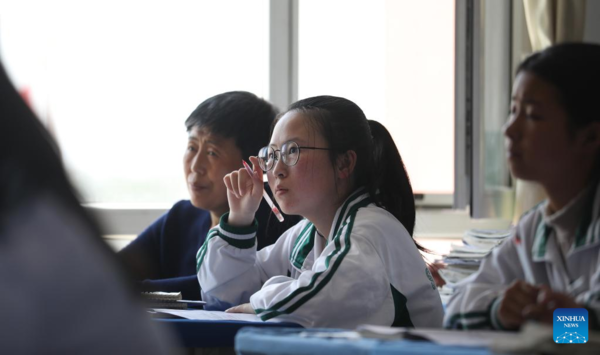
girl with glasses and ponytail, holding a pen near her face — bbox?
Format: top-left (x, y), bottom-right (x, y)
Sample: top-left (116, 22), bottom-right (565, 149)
top-left (197, 96), bottom-right (443, 328)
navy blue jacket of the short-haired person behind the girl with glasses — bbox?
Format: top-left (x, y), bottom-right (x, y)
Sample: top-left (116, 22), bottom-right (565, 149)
top-left (119, 200), bottom-right (300, 300)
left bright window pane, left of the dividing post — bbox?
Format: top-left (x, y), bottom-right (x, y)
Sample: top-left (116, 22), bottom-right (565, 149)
top-left (0, 0), bottom-right (269, 206)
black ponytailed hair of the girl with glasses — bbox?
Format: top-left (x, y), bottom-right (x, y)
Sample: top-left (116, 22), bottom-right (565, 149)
top-left (288, 96), bottom-right (425, 243)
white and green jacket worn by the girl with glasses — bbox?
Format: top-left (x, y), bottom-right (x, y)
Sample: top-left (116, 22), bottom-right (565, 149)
top-left (197, 190), bottom-right (443, 328)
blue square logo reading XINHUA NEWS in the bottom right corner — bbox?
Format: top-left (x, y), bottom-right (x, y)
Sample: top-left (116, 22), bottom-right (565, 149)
top-left (552, 308), bottom-right (588, 344)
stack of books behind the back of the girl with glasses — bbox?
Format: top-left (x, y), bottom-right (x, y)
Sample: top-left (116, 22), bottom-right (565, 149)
top-left (438, 229), bottom-right (512, 300)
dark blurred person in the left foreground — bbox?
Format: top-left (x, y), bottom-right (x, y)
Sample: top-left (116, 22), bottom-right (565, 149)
top-left (0, 60), bottom-right (176, 354)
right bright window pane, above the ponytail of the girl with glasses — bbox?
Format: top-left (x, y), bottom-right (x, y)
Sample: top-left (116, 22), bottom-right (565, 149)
top-left (298, 0), bottom-right (455, 197)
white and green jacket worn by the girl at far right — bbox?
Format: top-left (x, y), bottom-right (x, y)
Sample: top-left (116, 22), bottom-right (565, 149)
top-left (444, 182), bottom-right (600, 329)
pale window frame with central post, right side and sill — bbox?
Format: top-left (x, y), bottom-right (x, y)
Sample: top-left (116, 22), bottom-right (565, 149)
top-left (91, 0), bottom-right (512, 234)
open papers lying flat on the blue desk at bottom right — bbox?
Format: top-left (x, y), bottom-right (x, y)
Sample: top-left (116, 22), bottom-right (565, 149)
top-left (356, 325), bottom-right (518, 347)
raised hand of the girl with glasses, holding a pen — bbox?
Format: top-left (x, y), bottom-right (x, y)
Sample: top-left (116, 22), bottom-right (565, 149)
top-left (223, 157), bottom-right (283, 227)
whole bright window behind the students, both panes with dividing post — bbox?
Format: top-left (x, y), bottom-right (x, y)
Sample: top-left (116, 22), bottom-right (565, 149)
top-left (0, 0), bottom-right (511, 233)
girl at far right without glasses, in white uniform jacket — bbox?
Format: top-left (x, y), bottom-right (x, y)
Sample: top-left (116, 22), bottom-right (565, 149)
top-left (444, 44), bottom-right (600, 329)
